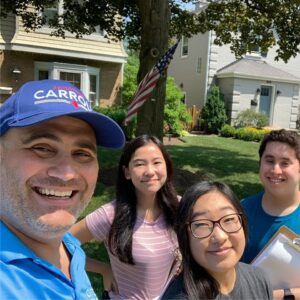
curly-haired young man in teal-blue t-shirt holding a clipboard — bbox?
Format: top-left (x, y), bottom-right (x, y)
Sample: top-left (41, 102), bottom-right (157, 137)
top-left (242, 129), bottom-right (300, 299)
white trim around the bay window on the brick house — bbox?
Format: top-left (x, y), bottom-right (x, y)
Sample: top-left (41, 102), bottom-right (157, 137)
top-left (34, 61), bottom-right (100, 106)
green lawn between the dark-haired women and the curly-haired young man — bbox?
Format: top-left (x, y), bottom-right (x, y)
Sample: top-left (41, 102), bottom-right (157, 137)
top-left (167, 135), bottom-right (261, 198)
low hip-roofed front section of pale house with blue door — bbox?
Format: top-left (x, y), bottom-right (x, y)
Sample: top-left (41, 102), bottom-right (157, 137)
top-left (216, 56), bottom-right (300, 129)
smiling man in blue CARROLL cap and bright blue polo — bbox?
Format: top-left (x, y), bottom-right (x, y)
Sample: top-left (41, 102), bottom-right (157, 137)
top-left (0, 80), bottom-right (124, 299)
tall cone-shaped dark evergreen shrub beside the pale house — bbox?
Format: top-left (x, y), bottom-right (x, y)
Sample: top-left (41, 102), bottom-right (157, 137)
top-left (200, 86), bottom-right (227, 133)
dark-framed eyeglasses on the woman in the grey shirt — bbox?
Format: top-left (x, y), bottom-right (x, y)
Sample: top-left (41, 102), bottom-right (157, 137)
top-left (189, 213), bottom-right (242, 239)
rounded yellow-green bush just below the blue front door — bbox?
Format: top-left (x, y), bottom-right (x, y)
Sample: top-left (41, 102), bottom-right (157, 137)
top-left (234, 108), bottom-right (269, 128)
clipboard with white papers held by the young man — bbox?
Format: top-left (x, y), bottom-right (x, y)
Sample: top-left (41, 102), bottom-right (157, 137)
top-left (251, 226), bottom-right (300, 289)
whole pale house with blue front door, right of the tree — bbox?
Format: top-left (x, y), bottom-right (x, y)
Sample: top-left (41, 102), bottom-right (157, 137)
top-left (168, 1), bottom-right (300, 129)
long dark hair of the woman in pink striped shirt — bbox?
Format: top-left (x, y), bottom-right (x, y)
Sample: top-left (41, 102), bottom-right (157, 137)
top-left (108, 135), bottom-right (178, 265)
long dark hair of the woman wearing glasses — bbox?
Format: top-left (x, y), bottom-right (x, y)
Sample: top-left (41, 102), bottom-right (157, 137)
top-left (176, 181), bottom-right (248, 299)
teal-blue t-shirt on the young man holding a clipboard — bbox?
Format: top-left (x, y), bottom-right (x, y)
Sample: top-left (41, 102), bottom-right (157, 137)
top-left (241, 192), bottom-right (300, 263)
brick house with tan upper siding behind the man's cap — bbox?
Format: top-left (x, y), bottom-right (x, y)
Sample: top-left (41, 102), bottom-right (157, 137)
top-left (0, 6), bottom-right (127, 106)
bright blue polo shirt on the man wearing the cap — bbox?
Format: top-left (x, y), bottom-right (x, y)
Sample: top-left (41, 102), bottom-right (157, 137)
top-left (0, 222), bottom-right (97, 300)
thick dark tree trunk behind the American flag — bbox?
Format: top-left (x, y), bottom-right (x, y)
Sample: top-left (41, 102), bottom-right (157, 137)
top-left (136, 0), bottom-right (170, 139)
